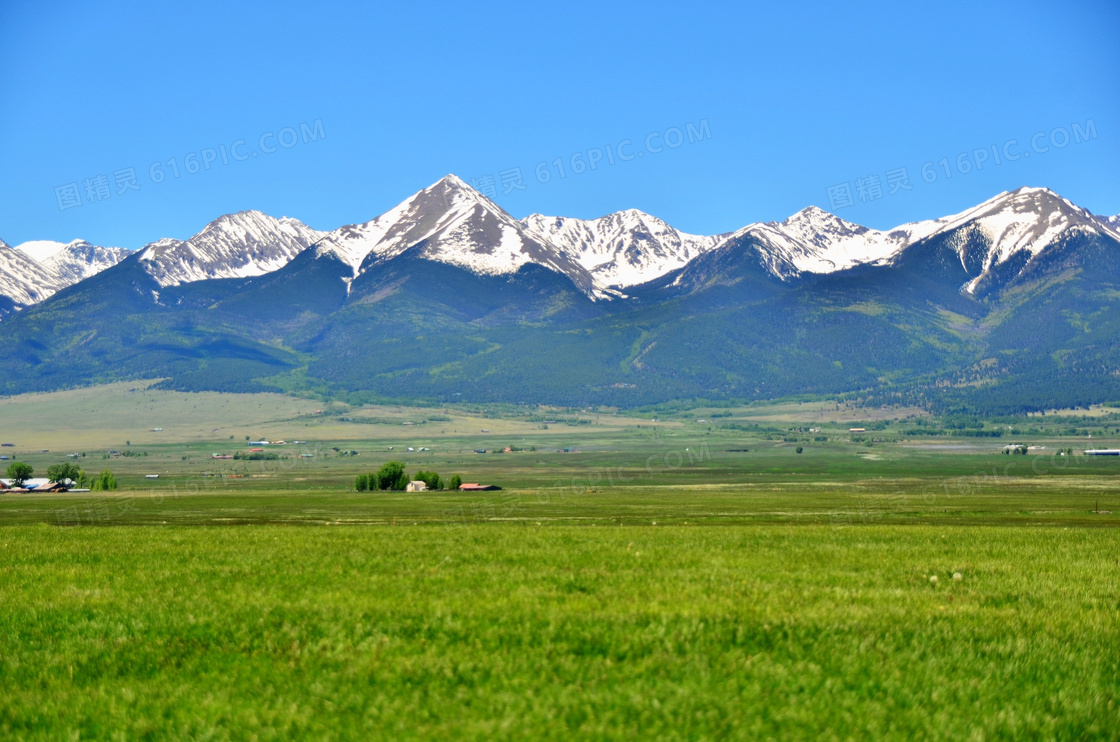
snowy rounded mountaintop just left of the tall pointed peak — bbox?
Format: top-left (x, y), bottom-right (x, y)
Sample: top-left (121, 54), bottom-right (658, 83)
top-left (140, 211), bottom-right (325, 286)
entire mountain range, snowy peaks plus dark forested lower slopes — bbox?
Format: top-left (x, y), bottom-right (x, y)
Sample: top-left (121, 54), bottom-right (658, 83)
top-left (0, 176), bottom-right (1120, 411)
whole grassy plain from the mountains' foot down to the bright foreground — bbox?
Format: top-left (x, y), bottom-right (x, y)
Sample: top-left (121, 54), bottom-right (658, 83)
top-left (0, 386), bottom-right (1120, 740)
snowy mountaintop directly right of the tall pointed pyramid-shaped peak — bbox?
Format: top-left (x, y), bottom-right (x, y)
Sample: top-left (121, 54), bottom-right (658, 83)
top-left (521, 208), bottom-right (720, 289)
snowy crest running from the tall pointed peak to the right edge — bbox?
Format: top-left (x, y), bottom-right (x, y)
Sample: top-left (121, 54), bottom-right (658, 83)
top-left (252, 182), bottom-right (1117, 298)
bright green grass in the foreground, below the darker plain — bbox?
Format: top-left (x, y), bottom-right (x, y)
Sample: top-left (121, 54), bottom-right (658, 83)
top-left (0, 526), bottom-right (1120, 739)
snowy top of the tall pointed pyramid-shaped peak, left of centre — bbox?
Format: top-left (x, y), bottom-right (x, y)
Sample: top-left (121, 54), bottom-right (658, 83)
top-left (316, 175), bottom-right (594, 291)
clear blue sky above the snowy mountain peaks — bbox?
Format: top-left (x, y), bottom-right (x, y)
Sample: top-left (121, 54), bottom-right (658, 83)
top-left (0, 0), bottom-right (1120, 248)
